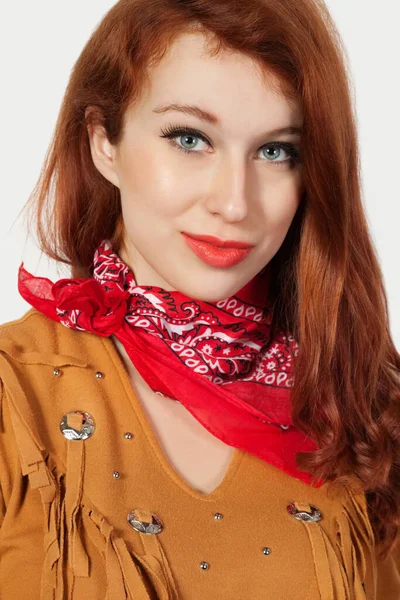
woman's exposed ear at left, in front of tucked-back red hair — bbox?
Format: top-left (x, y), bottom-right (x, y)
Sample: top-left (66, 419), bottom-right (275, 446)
top-left (85, 107), bottom-right (120, 188)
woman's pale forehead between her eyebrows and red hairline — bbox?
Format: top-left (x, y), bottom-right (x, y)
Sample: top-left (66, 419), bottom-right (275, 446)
top-left (134, 32), bottom-right (301, 127)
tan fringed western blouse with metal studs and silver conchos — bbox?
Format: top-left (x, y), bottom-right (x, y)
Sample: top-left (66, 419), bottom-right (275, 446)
top-left (0, 309), bottom-right (400, 600)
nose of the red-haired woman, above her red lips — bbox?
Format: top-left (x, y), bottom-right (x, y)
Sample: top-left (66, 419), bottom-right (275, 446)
top-left (207, 158), bottom-right (250, 223)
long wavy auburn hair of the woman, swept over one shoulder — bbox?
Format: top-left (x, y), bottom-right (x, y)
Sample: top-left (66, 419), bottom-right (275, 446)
top-left (21, 0), bottom-right (400, 558)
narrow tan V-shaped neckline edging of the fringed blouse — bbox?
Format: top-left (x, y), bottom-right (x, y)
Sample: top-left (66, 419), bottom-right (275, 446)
top-left (100, 337), bottom-right (246, 502)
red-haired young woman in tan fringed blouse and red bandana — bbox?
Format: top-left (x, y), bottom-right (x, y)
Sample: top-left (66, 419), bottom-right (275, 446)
top-left (0, 0), bottom-right (400, 600)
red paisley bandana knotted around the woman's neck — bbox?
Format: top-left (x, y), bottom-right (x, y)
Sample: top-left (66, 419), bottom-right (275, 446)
top-left (18, 240), bottom-right (323, 487)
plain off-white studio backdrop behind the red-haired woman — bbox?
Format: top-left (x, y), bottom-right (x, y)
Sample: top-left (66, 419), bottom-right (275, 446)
top-left (0, 0), bottom-right (400, 350)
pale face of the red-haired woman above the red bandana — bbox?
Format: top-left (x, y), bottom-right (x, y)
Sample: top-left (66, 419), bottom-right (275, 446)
top-left (89, 33), bottom-right (303, 302)
